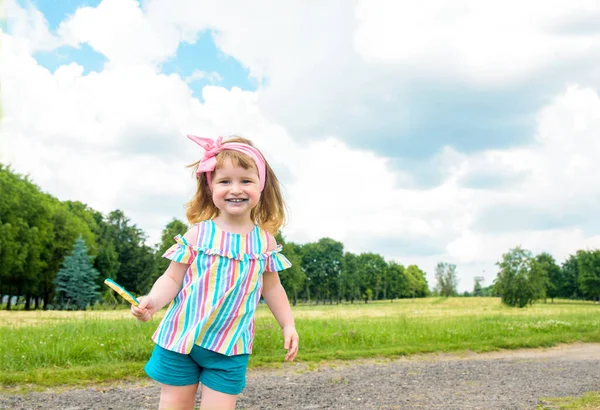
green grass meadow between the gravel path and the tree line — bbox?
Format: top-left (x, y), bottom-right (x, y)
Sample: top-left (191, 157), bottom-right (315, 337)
top-left (0, 298), bottom-right (600, 389)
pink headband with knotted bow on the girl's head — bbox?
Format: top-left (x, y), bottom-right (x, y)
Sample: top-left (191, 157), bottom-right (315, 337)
top-left (187, 134), bottom-right (267, 192)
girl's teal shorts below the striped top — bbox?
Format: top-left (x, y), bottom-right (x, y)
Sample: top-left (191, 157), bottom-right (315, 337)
top-left (144, 345), bottom-right (250, 394)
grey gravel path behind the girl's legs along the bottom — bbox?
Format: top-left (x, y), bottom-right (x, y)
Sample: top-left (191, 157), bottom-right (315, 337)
top-left (0, 344), bottom-right (600, 410)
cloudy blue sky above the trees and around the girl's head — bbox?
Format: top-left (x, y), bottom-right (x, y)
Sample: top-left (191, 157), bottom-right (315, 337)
top-left (0, 0), bottom-right (600, 292)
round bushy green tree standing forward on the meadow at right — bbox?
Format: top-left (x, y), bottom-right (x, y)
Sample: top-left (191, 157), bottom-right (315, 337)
top-left (495, 246), bottom-right (547, 307)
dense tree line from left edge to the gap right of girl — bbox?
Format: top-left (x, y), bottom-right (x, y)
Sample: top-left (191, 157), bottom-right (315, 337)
top-left (0, 164), bottom-right (429, 310)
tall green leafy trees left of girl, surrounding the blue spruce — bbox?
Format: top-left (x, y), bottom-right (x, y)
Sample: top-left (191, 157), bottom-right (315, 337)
top-left (0, 164), bottom-right (156, 309)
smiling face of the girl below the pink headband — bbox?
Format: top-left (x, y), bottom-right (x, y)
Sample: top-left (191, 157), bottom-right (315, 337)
top-left (212, 160), bottom-right (260, 218)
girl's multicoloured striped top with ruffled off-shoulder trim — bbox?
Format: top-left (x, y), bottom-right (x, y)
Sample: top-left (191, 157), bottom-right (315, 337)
top-left (152, 220), bottom-right (292, 356)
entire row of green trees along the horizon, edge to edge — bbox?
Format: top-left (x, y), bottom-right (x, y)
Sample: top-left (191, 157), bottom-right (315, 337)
top-left (0, 164), bottom-right (600, 309)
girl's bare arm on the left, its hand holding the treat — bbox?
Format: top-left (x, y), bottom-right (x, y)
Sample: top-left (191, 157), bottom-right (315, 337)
top-left (131, 228), bottom-right (197, 322)
